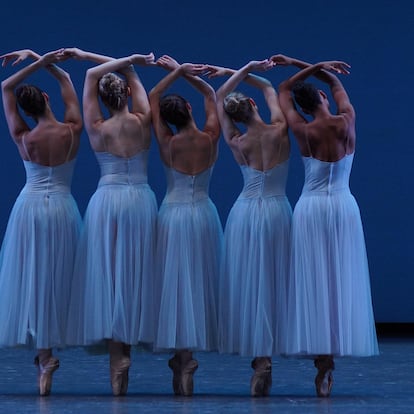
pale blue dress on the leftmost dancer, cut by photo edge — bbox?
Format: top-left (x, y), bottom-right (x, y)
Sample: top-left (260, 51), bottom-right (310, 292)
top-left (0, 160), bottom-right (81, 349)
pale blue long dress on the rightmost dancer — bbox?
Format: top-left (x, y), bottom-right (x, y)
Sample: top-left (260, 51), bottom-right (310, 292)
top-left (286, 154), bottom-right (378, 356)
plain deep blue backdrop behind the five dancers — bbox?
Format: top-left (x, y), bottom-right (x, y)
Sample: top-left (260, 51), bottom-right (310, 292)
top-left (0, 0), bottom-right (414, 322)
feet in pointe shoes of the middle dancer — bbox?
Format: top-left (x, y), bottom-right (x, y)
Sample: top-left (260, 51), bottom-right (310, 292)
top-left (168, 351), bottom-right (198, 397)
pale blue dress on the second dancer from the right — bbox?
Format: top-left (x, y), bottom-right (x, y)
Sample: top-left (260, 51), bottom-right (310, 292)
top-left (219, 160), bottom-right (292, 357)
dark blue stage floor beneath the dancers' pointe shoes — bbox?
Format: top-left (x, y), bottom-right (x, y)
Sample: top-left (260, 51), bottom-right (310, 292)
top-left (0, 337), bottom-right (414, 414)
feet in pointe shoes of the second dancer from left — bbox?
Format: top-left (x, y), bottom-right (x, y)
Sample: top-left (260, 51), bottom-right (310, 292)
top-left (109, 341), bottom-right (131, 396)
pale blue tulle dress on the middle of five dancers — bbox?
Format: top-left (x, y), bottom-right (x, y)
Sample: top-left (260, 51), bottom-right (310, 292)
top-left (156, 167), bottom-right (222, 351)
